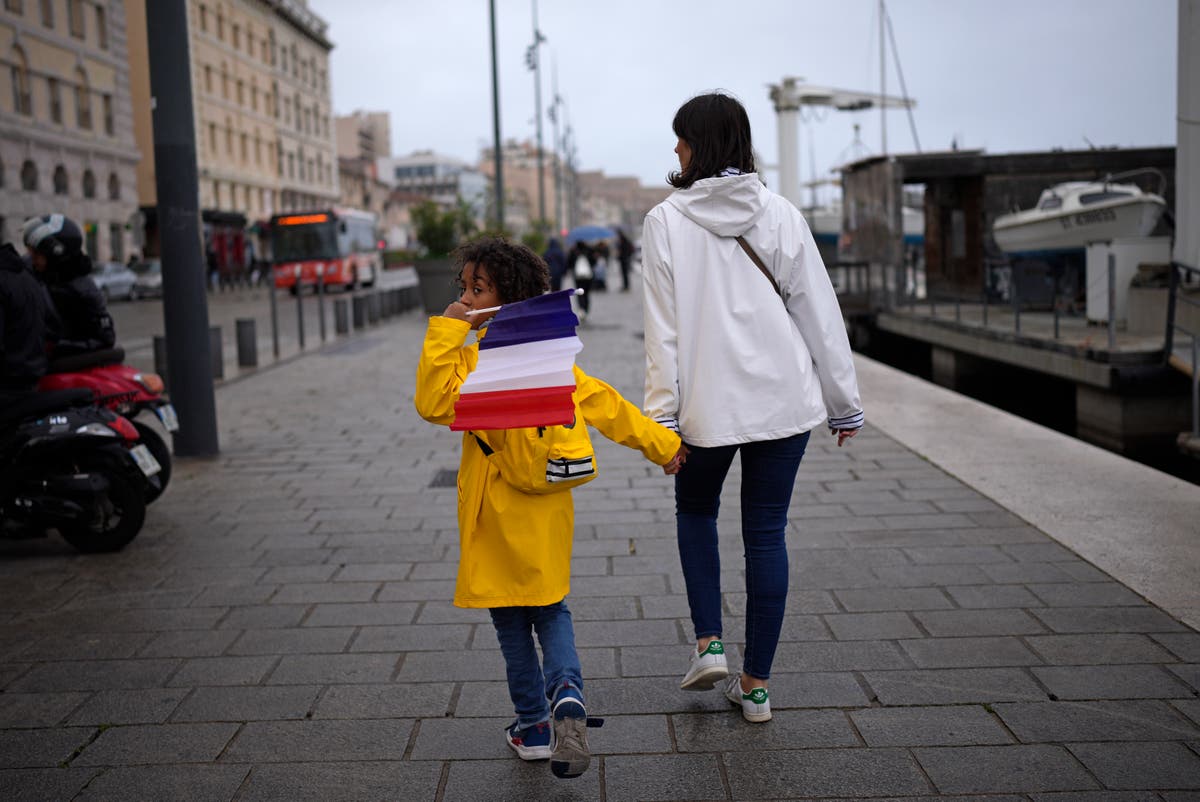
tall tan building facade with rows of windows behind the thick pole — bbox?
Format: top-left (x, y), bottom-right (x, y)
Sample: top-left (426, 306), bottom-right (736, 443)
top-left (125, 0), bottom-right (338, 230)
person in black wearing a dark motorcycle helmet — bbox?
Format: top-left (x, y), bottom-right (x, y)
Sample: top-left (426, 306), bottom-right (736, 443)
top-left (22, 215), bottom-right (116, 359)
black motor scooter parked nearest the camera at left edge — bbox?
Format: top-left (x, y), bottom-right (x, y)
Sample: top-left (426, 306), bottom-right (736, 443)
top-left (0, 390), bottom-right (160, 552)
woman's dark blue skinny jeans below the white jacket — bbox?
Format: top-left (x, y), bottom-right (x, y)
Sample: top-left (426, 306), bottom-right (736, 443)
top-left (676, 432), bottom-right (810, 680)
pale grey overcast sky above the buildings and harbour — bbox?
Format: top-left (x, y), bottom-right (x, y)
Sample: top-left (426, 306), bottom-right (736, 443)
top-left (310, 0), bottom-right (1177, 199)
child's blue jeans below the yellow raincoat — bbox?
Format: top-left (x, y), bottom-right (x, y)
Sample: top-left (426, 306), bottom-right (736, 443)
top-left (488, 602), bottom-right (583, 729)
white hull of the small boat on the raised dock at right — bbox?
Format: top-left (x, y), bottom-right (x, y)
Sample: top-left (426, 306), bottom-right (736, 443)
top-left (992, 198), bottom-right (1165, 253)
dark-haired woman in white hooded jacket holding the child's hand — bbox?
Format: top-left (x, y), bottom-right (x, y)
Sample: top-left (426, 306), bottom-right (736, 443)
top-left (642, 94), bottom-right (863, 722)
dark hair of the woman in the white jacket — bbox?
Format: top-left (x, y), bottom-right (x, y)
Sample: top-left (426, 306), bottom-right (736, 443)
top-left (667, 92), bottom-right (755, 190)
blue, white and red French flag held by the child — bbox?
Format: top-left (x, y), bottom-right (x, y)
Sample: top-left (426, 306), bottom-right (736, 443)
top-left (450, 289), bottom-right (583, 431)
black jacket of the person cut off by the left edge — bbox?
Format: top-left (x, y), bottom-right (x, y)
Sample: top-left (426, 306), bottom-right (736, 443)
top-left (0, 244), bottom-right (54, 391)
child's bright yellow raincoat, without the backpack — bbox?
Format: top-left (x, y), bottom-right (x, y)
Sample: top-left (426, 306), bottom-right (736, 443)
top-left (414, 317), bottom-right (679, 608)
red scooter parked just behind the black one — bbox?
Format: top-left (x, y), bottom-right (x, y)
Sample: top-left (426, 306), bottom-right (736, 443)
top-left (37, 348), bottom-right (179, 503)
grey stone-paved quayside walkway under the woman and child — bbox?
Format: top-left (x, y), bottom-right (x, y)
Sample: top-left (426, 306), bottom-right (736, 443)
top-left (0, 282), bottom-right (1200, 801)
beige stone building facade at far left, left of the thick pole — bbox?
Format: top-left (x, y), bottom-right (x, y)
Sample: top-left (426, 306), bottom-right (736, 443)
top-left (0, 0), bottom-right (138, 261)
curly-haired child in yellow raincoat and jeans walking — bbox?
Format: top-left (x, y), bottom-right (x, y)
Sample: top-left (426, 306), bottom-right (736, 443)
top-left (415, 238), bottom-right (684, 777)
